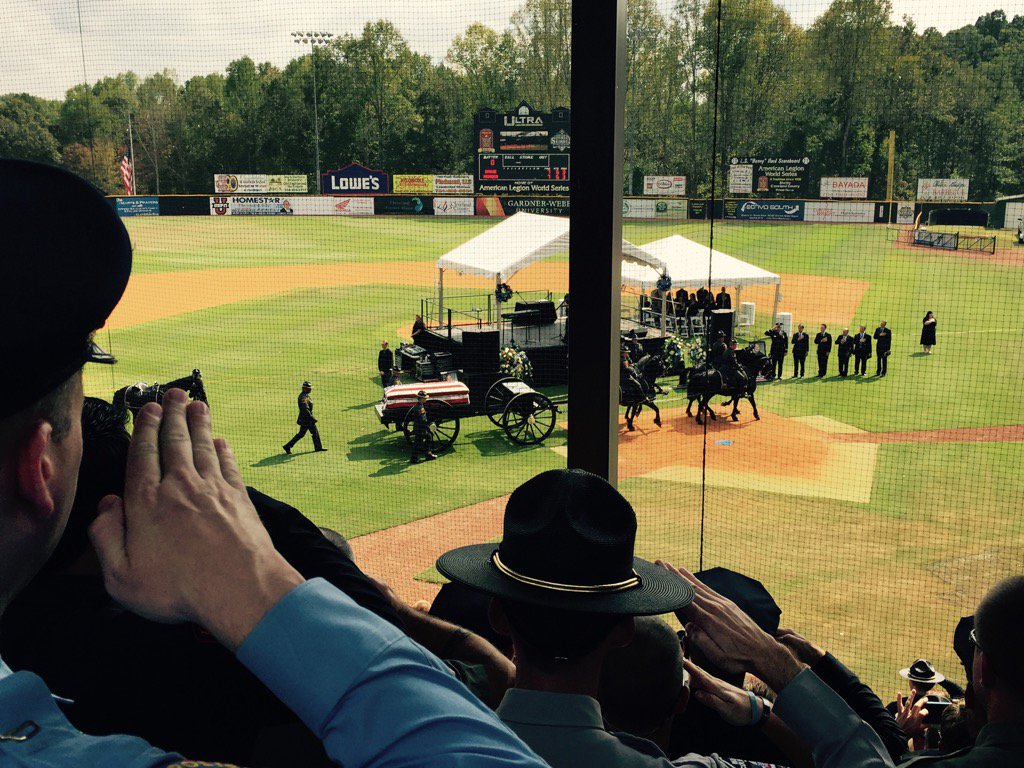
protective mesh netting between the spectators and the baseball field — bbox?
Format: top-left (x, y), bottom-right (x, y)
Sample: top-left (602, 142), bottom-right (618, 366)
top-left (0, 0), bottom-right (1024, 716)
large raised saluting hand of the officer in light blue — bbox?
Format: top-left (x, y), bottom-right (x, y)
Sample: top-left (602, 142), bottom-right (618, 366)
top-left (89, 389), bottom-right (302, 650)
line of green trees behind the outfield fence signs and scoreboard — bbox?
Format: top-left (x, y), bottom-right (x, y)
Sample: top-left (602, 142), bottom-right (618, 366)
top-left (0, 0), bottom-right (1024, 200)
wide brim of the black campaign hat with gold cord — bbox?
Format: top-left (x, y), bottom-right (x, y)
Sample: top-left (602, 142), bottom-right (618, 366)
top-left (437, 544), bottom-right (693, 616)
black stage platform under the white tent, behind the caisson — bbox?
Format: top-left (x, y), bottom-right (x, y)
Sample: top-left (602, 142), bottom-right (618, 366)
top-left (415, 317), bottom-right (670, 386)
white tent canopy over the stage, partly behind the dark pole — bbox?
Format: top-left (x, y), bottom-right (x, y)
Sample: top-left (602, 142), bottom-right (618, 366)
top-left (437, 212), bottom-right (664, 281)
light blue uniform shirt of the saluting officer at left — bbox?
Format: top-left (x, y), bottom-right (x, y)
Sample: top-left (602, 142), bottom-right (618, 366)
top-left (0, 579), bottom-right (546, 768)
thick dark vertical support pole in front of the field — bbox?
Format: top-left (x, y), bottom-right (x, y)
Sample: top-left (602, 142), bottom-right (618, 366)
top-left (569, 0), bottom-right (626, 484)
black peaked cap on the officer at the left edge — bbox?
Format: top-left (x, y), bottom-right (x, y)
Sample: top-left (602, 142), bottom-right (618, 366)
top-left (0, 159), bottom-right (131, 419)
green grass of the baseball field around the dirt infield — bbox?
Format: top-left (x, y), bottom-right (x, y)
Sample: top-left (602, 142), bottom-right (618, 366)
top-left (86, 217), bottom-right (1024, 690)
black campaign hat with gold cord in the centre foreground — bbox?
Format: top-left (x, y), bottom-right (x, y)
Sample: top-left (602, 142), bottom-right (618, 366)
top-left (437, 469), bottom-right (693, 615)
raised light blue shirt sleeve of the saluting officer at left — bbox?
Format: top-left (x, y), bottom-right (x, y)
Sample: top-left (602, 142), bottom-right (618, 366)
top-left (238, 579), bottom-right (545, 768)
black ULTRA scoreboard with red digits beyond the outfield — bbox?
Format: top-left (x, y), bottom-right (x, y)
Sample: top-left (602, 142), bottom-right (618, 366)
top-left (473, 101), bottom-right (570, 196)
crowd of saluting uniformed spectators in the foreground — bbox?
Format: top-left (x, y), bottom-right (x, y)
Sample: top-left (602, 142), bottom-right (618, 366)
top-left (0, 160), bottom-right (1024, 768)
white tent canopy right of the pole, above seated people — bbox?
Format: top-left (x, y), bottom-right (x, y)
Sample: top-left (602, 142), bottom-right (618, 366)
top-left (623, 234), bottom-right (781, 288)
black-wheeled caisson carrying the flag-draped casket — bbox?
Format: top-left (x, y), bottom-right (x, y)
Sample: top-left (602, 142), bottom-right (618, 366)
top-left (374, 376), bottom-right (565, 453)
